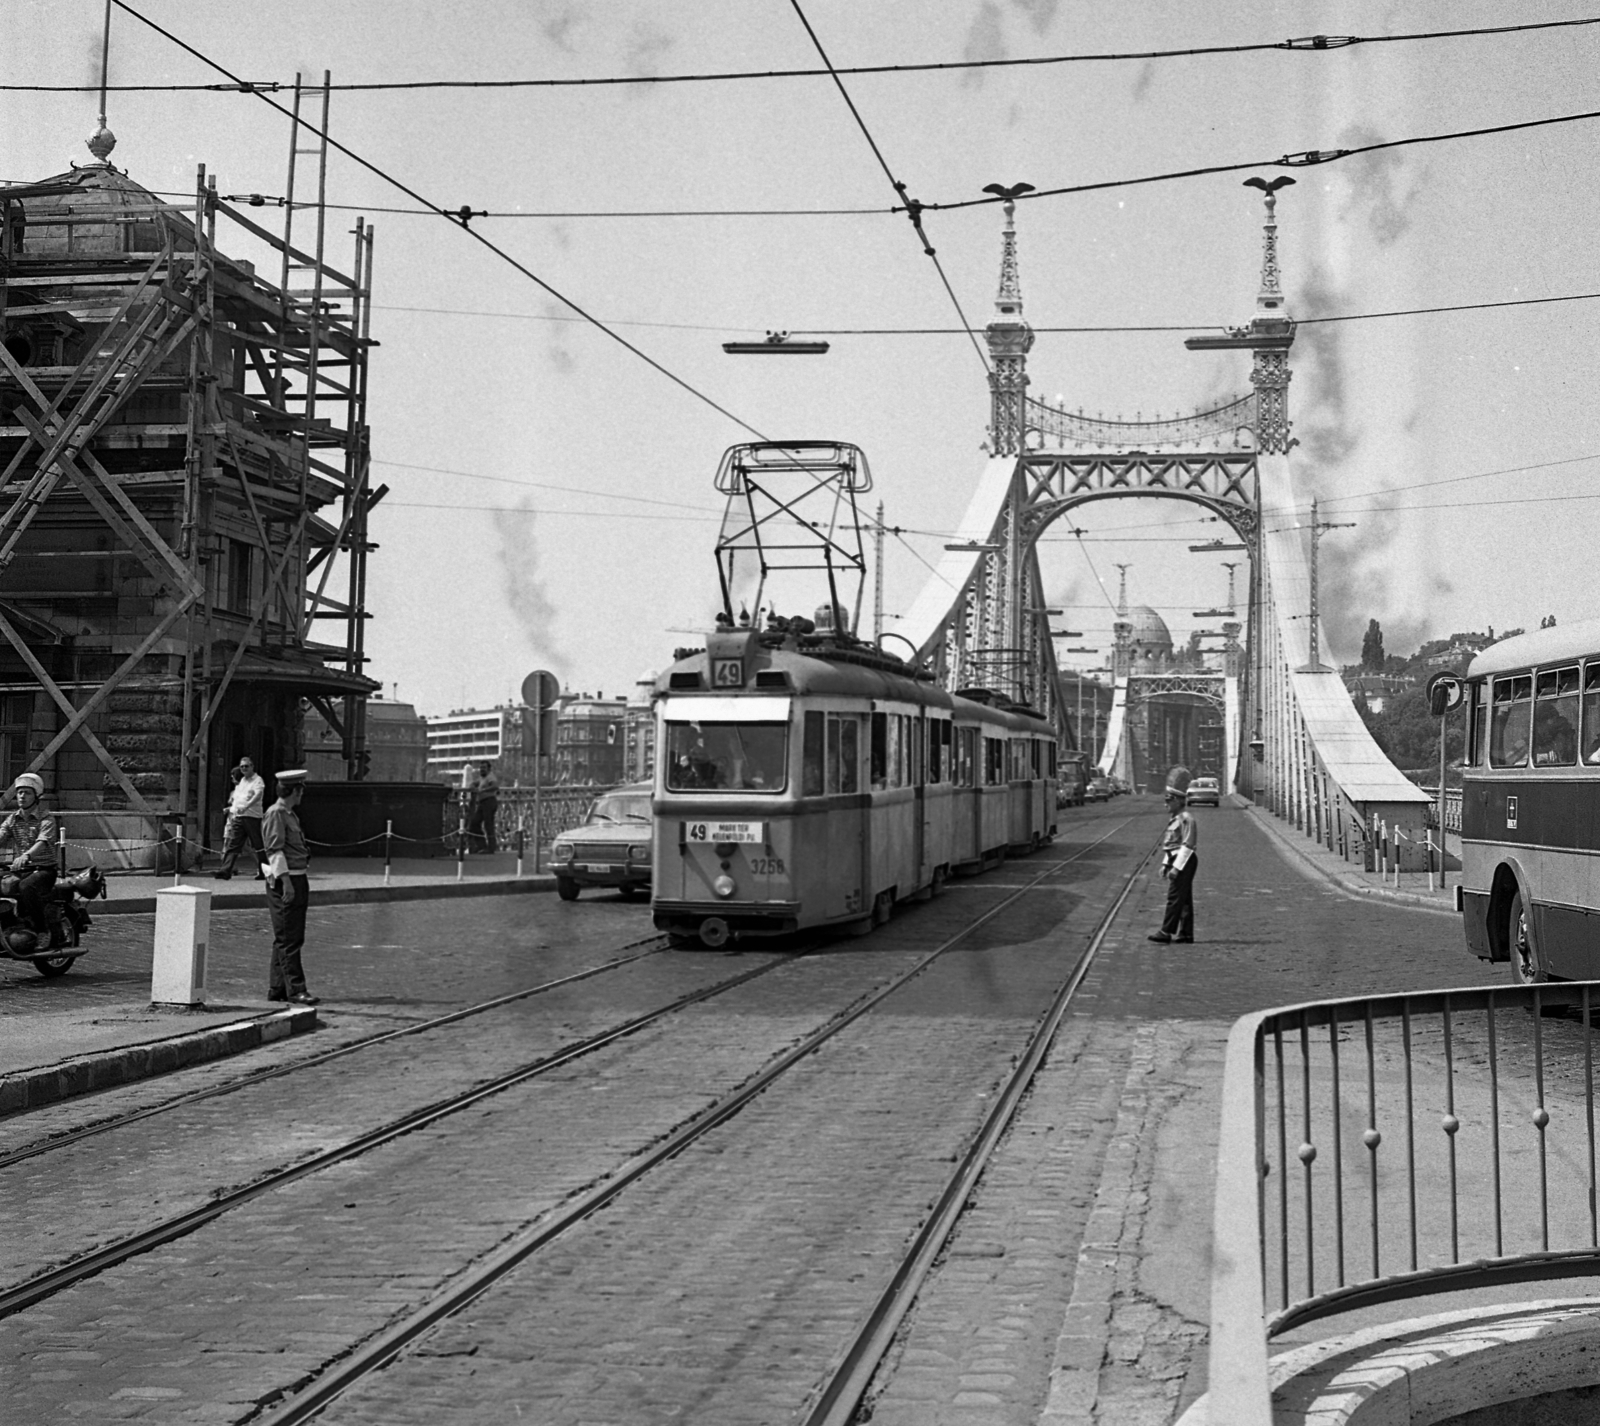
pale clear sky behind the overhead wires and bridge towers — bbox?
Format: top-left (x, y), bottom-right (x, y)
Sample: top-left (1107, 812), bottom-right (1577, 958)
top-left (0, 0), bottom-right (1600, 714)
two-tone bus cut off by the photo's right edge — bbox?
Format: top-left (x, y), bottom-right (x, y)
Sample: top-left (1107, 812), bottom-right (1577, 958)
top-left (1458, 619), bottom-right (1600, 983)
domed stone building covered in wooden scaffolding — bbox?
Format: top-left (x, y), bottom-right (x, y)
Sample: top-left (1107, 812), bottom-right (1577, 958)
top-left (0, 100), bottom-right (382, 864)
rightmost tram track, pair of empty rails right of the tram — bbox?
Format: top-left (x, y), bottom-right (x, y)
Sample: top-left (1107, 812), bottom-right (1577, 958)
top-left (245, 818), bottom-right (1154, 1426)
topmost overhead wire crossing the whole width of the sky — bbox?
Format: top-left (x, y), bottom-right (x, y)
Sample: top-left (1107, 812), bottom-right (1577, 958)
top-left (0, 18), bottom-right (1600, 94)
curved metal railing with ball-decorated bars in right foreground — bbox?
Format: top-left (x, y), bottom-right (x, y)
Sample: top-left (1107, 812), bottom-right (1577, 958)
top-left (1208, 981), bottom-right (1600, 1426)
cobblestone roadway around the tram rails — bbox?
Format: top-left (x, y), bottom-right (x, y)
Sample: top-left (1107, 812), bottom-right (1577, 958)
top-left (0, 800), bottom-right (1486, 1426)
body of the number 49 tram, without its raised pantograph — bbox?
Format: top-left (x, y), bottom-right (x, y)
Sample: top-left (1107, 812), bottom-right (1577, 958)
top-left (651, 610), bottom-right (1056, 947)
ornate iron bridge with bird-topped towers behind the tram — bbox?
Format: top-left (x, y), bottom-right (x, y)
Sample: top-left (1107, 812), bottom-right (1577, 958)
top-left (888, 190), bottom-right (1429, 866)
